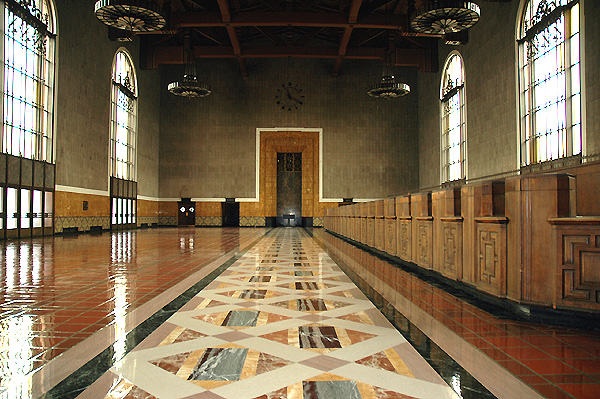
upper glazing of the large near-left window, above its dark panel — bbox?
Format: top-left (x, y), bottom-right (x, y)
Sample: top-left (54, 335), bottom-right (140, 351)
top-left (2, 0), bottom-right (55, 162)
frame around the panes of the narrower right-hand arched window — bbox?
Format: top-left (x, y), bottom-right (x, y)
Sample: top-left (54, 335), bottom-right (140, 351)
top-left (439, 50), bottom-right (468, 185)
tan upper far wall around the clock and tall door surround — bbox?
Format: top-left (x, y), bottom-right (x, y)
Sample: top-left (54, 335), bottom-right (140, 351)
top-left (160, 59), bottom-right (418, 202)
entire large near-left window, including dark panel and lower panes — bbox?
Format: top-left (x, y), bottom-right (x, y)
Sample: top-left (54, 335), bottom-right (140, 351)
top-left (0, 0), bottom-right (56, 238)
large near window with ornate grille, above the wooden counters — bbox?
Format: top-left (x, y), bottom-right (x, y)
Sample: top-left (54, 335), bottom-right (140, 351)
top-left (518, 0), bottom-right (582, 166)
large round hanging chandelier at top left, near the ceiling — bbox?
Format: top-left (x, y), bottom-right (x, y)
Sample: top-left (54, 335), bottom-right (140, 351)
top-left (94, 0), bottom-right (166, 32)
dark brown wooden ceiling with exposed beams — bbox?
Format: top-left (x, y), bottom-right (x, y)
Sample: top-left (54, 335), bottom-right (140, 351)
top-left (134, 0), bottom-right (510, 76)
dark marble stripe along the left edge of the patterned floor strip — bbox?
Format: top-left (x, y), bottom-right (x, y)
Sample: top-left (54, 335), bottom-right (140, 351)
top-left (41, 229), bottom-right (273, 399)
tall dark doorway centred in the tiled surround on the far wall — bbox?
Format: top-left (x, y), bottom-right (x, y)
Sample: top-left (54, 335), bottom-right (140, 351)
top-left (277, 152), bottom-right (302, 227)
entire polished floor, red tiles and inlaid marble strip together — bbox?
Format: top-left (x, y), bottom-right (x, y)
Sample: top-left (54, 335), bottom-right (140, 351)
top-left (0, 228), bottom-right (600, 399)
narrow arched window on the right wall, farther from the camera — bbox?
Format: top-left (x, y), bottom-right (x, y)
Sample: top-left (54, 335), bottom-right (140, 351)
top-left (440, 51), bottom-right (467, 183)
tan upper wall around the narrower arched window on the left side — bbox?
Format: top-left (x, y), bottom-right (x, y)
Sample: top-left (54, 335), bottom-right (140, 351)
top-left (55, 0), bottom-right (160, 197)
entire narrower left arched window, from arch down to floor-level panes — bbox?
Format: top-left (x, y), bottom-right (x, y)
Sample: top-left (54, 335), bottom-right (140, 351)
top-left (110, 49), bottom-right (137, 227)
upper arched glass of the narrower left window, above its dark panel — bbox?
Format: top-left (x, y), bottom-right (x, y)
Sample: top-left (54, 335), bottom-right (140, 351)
top-left (110, 50), bottom-right (137, 181)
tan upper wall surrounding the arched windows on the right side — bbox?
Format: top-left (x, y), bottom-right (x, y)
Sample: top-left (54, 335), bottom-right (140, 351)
top-left (419, 0), bottom-right (600, 188)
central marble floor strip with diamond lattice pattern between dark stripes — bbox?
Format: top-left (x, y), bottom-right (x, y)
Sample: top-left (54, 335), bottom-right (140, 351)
top-left (96, 229), bottom-right (458, 399)
